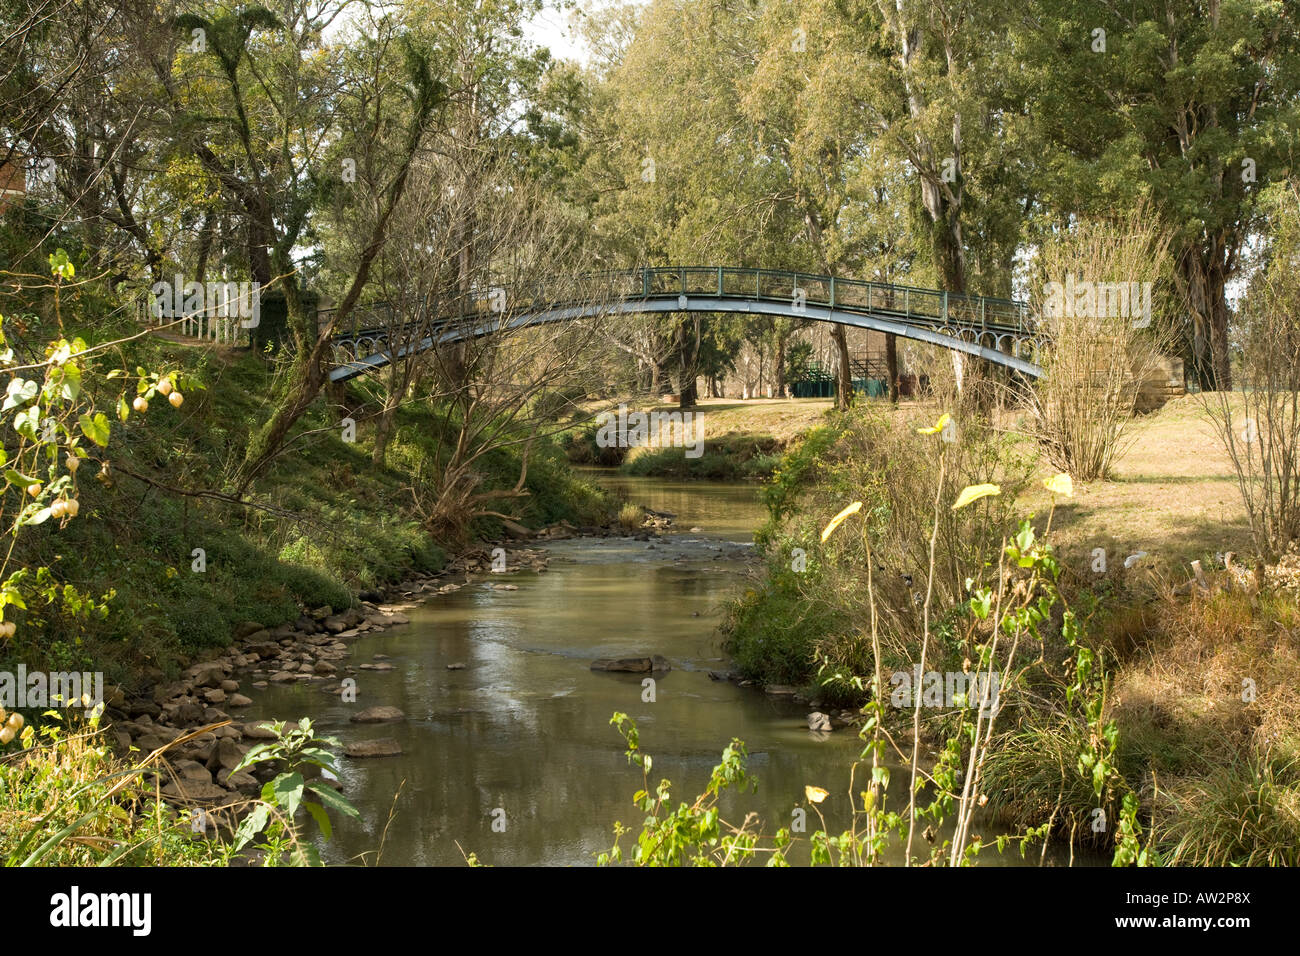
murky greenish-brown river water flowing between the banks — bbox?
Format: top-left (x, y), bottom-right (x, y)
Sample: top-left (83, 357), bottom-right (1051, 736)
top-left (247, 473), bottom-right (1076, 865)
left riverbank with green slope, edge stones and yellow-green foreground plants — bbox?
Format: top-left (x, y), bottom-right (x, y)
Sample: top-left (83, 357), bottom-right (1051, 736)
top-left (0, 323), bottom-right (611, 864)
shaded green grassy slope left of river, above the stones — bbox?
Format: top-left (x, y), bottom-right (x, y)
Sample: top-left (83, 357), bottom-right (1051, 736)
top-left (0, 316), bottom-right (608, 685)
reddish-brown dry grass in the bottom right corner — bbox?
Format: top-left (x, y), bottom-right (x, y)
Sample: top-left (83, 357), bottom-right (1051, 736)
top-left (1112, 591), bottom-right (1300, 866)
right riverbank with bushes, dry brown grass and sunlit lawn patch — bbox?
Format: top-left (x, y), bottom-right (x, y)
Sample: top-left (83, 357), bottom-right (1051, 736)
top-left (724, 398), bottom-right (1300, 865)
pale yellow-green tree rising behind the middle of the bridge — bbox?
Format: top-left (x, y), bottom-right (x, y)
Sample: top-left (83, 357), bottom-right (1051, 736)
top-left (586, 0), bottom-right (815, 402)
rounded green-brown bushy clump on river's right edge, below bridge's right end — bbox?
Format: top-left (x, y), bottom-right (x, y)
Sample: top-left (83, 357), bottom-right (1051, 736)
top-left (724, 397), bottom-right (1032, 700)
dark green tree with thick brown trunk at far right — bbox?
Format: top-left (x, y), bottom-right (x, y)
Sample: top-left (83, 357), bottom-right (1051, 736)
top-left (1014, 0), bottom-right (1300, 389)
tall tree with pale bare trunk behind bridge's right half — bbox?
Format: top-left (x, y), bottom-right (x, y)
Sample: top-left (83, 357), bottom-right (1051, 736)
top-left (818, 0), bottom-right (1032, 395)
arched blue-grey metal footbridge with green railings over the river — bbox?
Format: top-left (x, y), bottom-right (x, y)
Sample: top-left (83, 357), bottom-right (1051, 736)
top-left (329, 265), bottom-right (1047, 381)
